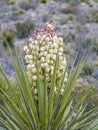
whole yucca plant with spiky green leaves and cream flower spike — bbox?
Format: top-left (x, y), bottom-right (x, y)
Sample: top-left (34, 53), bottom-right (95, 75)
top-left (0, 19), bottom-right (98, 130)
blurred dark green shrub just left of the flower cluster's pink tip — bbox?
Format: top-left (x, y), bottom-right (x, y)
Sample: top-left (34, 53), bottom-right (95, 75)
top-left (15, 21), bottom-right (34, 38)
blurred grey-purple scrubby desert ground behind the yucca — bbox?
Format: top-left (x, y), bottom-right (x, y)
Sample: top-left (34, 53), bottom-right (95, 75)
top-left (0, 0), bottom-right (98, 87)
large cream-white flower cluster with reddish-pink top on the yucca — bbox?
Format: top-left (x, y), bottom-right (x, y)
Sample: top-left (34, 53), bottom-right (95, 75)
top-left (24, 20), bottom-right (67, 98)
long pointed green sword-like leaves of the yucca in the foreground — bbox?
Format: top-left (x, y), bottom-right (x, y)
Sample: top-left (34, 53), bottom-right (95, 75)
top-left (0, 50), bottom-right (98, 130)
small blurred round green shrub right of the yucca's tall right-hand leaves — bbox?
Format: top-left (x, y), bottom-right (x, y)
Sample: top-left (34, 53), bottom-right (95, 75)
top-left (82, 62), bottom-right (94, 75)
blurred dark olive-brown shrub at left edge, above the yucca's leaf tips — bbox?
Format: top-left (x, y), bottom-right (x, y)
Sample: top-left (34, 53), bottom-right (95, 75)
top-left (0, 29), bottom-right (15, 48)
